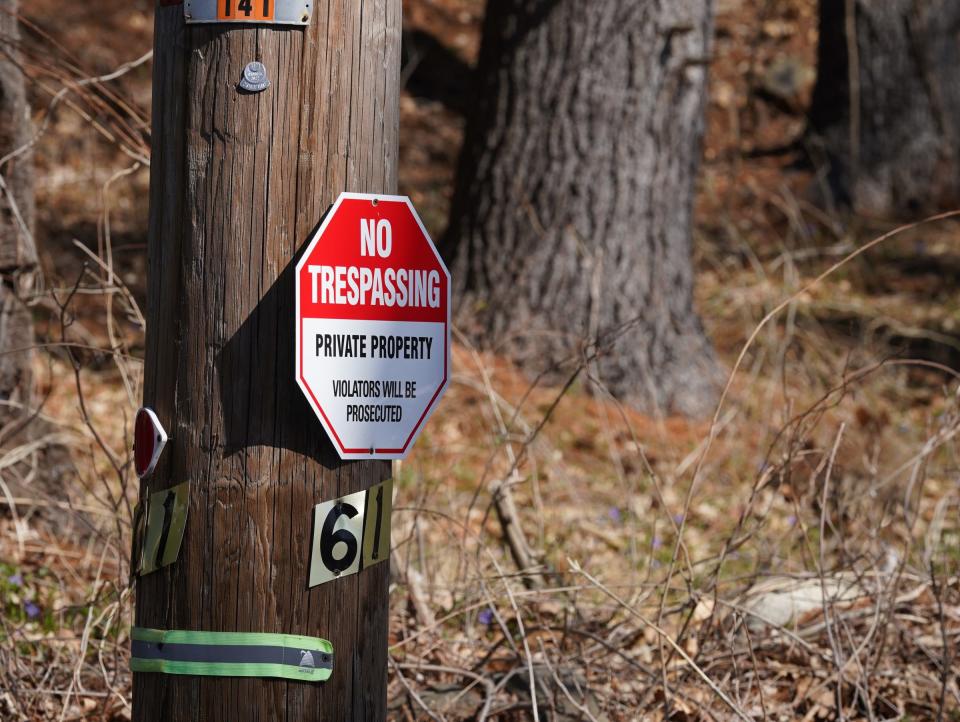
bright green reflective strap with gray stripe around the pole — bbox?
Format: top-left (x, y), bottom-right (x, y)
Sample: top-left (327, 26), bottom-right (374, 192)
top-left (130, 627), bottom-right (333, 682)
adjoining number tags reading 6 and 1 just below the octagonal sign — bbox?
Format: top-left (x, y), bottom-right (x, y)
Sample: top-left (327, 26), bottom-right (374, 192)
top-left (309, 480), bottom-right (393, 587)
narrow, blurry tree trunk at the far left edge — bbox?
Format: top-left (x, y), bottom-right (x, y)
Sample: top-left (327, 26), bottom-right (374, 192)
top-left (0, 0), bottom-right (37, 438)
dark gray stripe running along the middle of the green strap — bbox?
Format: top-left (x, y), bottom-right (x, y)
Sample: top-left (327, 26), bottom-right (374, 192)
top-left (130, 639), bottom-right (333, 669)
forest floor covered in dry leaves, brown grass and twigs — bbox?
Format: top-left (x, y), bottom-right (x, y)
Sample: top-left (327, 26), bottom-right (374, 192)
top-left (0, 0), bottom-right (960, 720)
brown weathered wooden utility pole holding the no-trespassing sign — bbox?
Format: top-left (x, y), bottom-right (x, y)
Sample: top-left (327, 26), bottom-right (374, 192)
top-left (133, 0), bottom-right (401, 722)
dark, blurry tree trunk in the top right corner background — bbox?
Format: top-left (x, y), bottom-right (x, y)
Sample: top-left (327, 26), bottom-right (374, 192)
top-left (811, 0), bottom-right (960, 216)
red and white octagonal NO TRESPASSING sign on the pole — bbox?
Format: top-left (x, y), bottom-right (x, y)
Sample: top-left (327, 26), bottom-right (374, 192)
top-left (296, 193), bottom-right (450, 459)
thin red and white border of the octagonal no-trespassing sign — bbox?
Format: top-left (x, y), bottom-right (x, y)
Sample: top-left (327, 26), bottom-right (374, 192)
top-left (294, 192), bottom-right (451, 460)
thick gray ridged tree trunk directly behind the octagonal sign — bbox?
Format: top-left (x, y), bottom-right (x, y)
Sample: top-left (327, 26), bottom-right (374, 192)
top-left (443, 0), bottom-right (716, 414)
